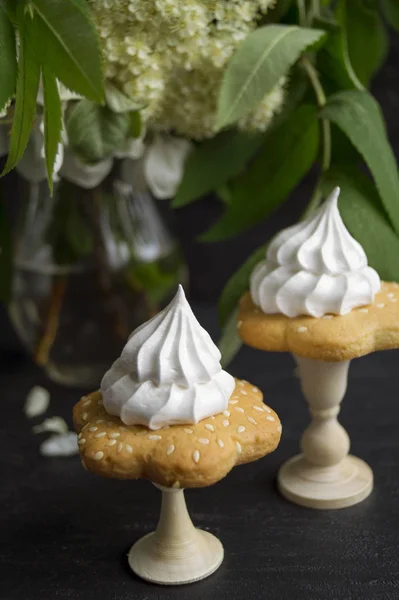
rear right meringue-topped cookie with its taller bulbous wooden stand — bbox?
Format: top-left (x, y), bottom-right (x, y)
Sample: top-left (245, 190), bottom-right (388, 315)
top-left (238, 188), bottom-right (399, 509)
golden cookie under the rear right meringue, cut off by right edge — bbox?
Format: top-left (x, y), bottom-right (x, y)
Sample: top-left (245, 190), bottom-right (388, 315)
top-left (238, 282), bottom-right (399, 362)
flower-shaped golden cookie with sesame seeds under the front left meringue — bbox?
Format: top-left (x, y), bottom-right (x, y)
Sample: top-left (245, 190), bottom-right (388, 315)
top-left (73, 380), bottom-right (281, 488)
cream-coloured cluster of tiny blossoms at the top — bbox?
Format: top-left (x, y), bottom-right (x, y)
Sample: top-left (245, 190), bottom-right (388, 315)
top-left (90, 0), bottom-right (283, 139)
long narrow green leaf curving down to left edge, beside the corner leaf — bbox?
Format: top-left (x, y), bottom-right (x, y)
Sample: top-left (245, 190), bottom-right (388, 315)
top-left (2, 4), bottom-right (40, 175)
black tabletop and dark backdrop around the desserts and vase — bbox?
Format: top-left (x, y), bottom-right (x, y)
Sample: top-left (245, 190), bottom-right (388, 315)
top-left (0, 31), bottom-right (399, 600)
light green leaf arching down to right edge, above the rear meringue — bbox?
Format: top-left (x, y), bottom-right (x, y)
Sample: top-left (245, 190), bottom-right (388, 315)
top-left (321, 90), bottom-right (399, 233)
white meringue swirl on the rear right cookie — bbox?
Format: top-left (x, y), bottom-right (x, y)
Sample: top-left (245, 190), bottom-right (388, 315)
top-left (250, 188), bottom-right (381, 317)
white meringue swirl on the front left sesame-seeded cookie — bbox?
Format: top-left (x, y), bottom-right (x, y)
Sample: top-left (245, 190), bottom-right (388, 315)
top-left (101, 286), bottom-right (235, 430)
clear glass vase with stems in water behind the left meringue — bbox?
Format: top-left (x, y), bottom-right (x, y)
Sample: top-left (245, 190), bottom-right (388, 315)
top-left (9, 165), bottom-right (187, 388)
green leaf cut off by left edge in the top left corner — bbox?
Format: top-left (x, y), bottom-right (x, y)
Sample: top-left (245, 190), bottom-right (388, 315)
top-left (0, 4), bottom-right (17, 111)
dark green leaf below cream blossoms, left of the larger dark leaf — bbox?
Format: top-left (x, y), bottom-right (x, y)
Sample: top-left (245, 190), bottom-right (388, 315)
top-left (173, 130), bottom-right (264, 208)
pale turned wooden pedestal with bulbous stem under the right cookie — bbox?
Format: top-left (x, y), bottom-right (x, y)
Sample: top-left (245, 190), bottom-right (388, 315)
top-left (278, 356), bottom-right (373, 509)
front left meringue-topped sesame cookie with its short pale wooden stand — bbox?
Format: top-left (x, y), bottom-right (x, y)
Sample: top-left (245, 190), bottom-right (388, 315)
top-left (74, 287), bottom-right (281, 584)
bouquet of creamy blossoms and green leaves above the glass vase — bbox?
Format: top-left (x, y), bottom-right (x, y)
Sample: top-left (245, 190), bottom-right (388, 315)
top-left (0, 0), bottom-right (399, 372)
